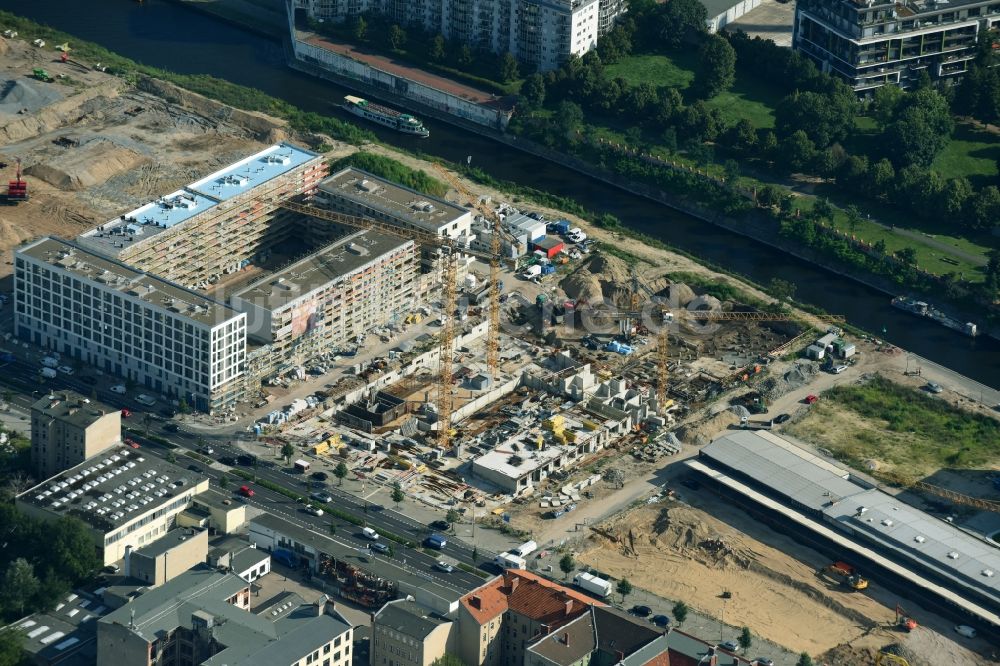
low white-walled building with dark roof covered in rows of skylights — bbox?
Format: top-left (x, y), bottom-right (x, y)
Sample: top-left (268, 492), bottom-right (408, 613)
top-left (16, 447), bottom-right (208, 564)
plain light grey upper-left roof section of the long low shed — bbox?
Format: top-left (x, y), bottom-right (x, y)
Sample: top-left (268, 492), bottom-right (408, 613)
top-left (700, 430), bottom-right (866, 510)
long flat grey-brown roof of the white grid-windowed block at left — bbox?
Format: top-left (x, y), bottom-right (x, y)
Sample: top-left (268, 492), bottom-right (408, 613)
top-left (17, 236), bottom-right (244, 326)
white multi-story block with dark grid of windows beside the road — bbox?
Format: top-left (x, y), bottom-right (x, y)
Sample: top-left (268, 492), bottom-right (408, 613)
top-left (14, 233), bottom-right (246, 411)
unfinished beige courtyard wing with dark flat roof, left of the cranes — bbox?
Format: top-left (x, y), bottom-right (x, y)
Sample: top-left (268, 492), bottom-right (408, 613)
top-left (229, 231), bottom-right (416, 360)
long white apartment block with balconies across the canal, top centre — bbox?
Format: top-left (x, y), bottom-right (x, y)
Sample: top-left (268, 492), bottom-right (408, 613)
top-left (293, 0), bottom-right (626, 72)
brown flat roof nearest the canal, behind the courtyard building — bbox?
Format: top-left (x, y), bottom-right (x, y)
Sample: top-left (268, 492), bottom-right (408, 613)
top-left (319, 167), bottom-right (471, 234)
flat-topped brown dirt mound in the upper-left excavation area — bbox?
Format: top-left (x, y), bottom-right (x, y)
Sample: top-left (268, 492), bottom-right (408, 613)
top-left (25, 139), bottom-right (147, 191)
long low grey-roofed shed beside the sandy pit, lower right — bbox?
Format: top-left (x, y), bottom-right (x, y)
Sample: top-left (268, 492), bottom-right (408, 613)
top-left (687, 431), bottom-right (1000, 628)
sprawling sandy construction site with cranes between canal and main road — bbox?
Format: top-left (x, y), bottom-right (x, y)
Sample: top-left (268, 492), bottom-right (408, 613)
top-left (0, 29), bottom-right (990, 666)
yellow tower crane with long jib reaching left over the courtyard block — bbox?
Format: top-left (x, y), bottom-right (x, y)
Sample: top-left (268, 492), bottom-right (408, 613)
top-left (279, 201), bottom-right (490, 449)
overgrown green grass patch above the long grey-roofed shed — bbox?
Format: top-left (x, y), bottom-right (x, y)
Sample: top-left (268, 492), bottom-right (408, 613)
top-left (789, 377), bottom-right (1000, 478)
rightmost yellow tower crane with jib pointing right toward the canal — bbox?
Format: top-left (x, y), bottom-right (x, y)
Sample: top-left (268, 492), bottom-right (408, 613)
top-left (592, 300), bottom-right (845, 409)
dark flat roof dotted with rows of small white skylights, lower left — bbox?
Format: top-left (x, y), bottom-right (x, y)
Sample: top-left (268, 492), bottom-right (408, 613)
top-left (17, 446), bottom-right (208, 532)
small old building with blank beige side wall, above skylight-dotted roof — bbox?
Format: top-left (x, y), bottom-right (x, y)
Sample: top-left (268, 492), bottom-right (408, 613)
top-left (31, 391), bottom-right (122, 479)
